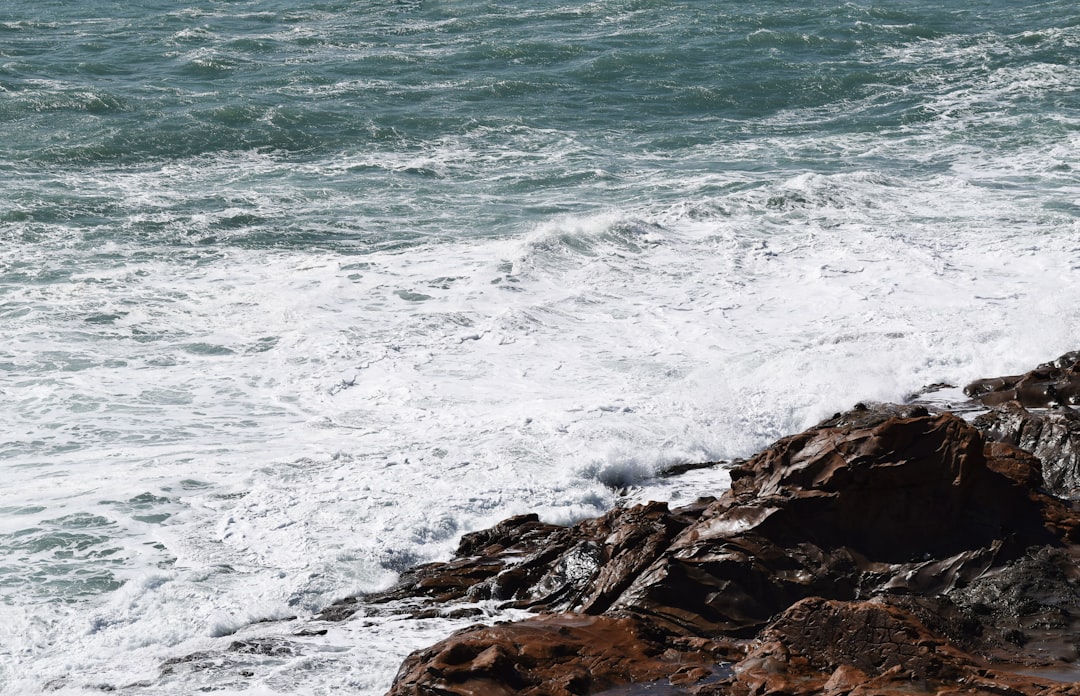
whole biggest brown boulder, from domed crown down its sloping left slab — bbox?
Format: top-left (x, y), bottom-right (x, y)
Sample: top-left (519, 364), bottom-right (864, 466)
top-left (615, 415), bottom-right (1078, 635)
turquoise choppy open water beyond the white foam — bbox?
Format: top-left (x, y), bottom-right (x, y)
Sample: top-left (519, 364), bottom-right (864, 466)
top-left (6, 1), bottom-right (1076, 251)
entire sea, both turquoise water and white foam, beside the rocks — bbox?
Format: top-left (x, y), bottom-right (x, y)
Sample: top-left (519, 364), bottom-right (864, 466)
top-left (0, 0), bottom-right (1080, 695)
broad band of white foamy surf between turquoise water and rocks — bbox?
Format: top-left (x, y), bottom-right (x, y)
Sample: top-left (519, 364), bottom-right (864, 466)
top-left (3, 184), bottom-right (1077, 693)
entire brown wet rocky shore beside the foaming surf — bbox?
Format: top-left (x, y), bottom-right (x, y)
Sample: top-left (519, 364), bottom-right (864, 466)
top-left (321, 352), bottom-right (1080, 696)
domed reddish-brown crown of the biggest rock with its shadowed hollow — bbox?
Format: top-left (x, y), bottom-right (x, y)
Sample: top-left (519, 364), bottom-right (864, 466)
top-left (725, 415), bottom-right (1019, 562)
